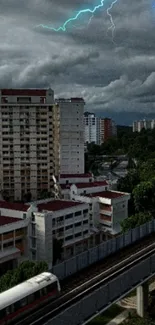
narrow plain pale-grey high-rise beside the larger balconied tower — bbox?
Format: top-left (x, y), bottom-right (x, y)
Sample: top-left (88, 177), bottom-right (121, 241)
top-left (55, 98), bottom-right (85, 174)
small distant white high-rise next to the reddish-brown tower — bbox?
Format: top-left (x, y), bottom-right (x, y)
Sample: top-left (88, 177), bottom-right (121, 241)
top-left (84, 112), bottom-right (100, 144)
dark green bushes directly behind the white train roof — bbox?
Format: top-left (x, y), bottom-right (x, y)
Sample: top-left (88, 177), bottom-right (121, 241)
top-left (0, 261), bottom-right (48, 292)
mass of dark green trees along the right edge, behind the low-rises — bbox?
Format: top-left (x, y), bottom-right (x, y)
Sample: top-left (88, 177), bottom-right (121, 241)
top-left (85, 129), bottom-right (155, 231)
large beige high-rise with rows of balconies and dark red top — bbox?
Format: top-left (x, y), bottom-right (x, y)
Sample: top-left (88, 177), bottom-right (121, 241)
top-left (0, 89), bottom-right (60, 200)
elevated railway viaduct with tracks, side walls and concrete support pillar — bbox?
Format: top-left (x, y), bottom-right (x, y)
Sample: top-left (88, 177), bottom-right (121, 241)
top-left (16, 220), bottom-right (155, 325)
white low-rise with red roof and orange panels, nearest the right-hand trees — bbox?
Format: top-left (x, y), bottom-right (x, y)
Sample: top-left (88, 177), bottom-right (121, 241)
top-left (71, 187), bottom-right (130, 235)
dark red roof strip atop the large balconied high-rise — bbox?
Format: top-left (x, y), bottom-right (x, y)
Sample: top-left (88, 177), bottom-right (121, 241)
top-left (1, 89), bottom-right (46, 96)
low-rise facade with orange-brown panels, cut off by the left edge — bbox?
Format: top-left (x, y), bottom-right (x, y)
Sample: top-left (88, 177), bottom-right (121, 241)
top-left (0, 215), bottom-right (29, 275)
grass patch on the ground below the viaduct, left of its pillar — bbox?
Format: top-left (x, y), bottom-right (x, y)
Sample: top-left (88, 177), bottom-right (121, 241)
top-left (89, 304), bottom-right (124, 325)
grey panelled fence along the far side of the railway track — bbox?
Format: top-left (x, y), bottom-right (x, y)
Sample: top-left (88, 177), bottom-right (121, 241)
top-left (52, 219), bottom-right (155, 280)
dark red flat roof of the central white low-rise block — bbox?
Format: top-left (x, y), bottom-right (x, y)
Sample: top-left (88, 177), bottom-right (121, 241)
top-left (37, 200), bottom-right (83, 212)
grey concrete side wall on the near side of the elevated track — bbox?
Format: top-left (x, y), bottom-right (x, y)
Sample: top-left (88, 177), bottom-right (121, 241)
top-left (46, 254), bottom-right (155, 325)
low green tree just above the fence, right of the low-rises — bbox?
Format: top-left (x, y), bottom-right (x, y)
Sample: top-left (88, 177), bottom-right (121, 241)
top-left (121, 212), bottom-right (152, 233)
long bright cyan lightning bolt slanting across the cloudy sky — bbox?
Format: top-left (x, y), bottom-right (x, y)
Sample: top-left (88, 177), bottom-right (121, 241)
top-left (37, 0), bottom-right (111, 32)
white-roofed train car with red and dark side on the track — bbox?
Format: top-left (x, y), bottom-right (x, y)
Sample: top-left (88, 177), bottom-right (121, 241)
top-left (0, 272), bottom-right (61, 325)
